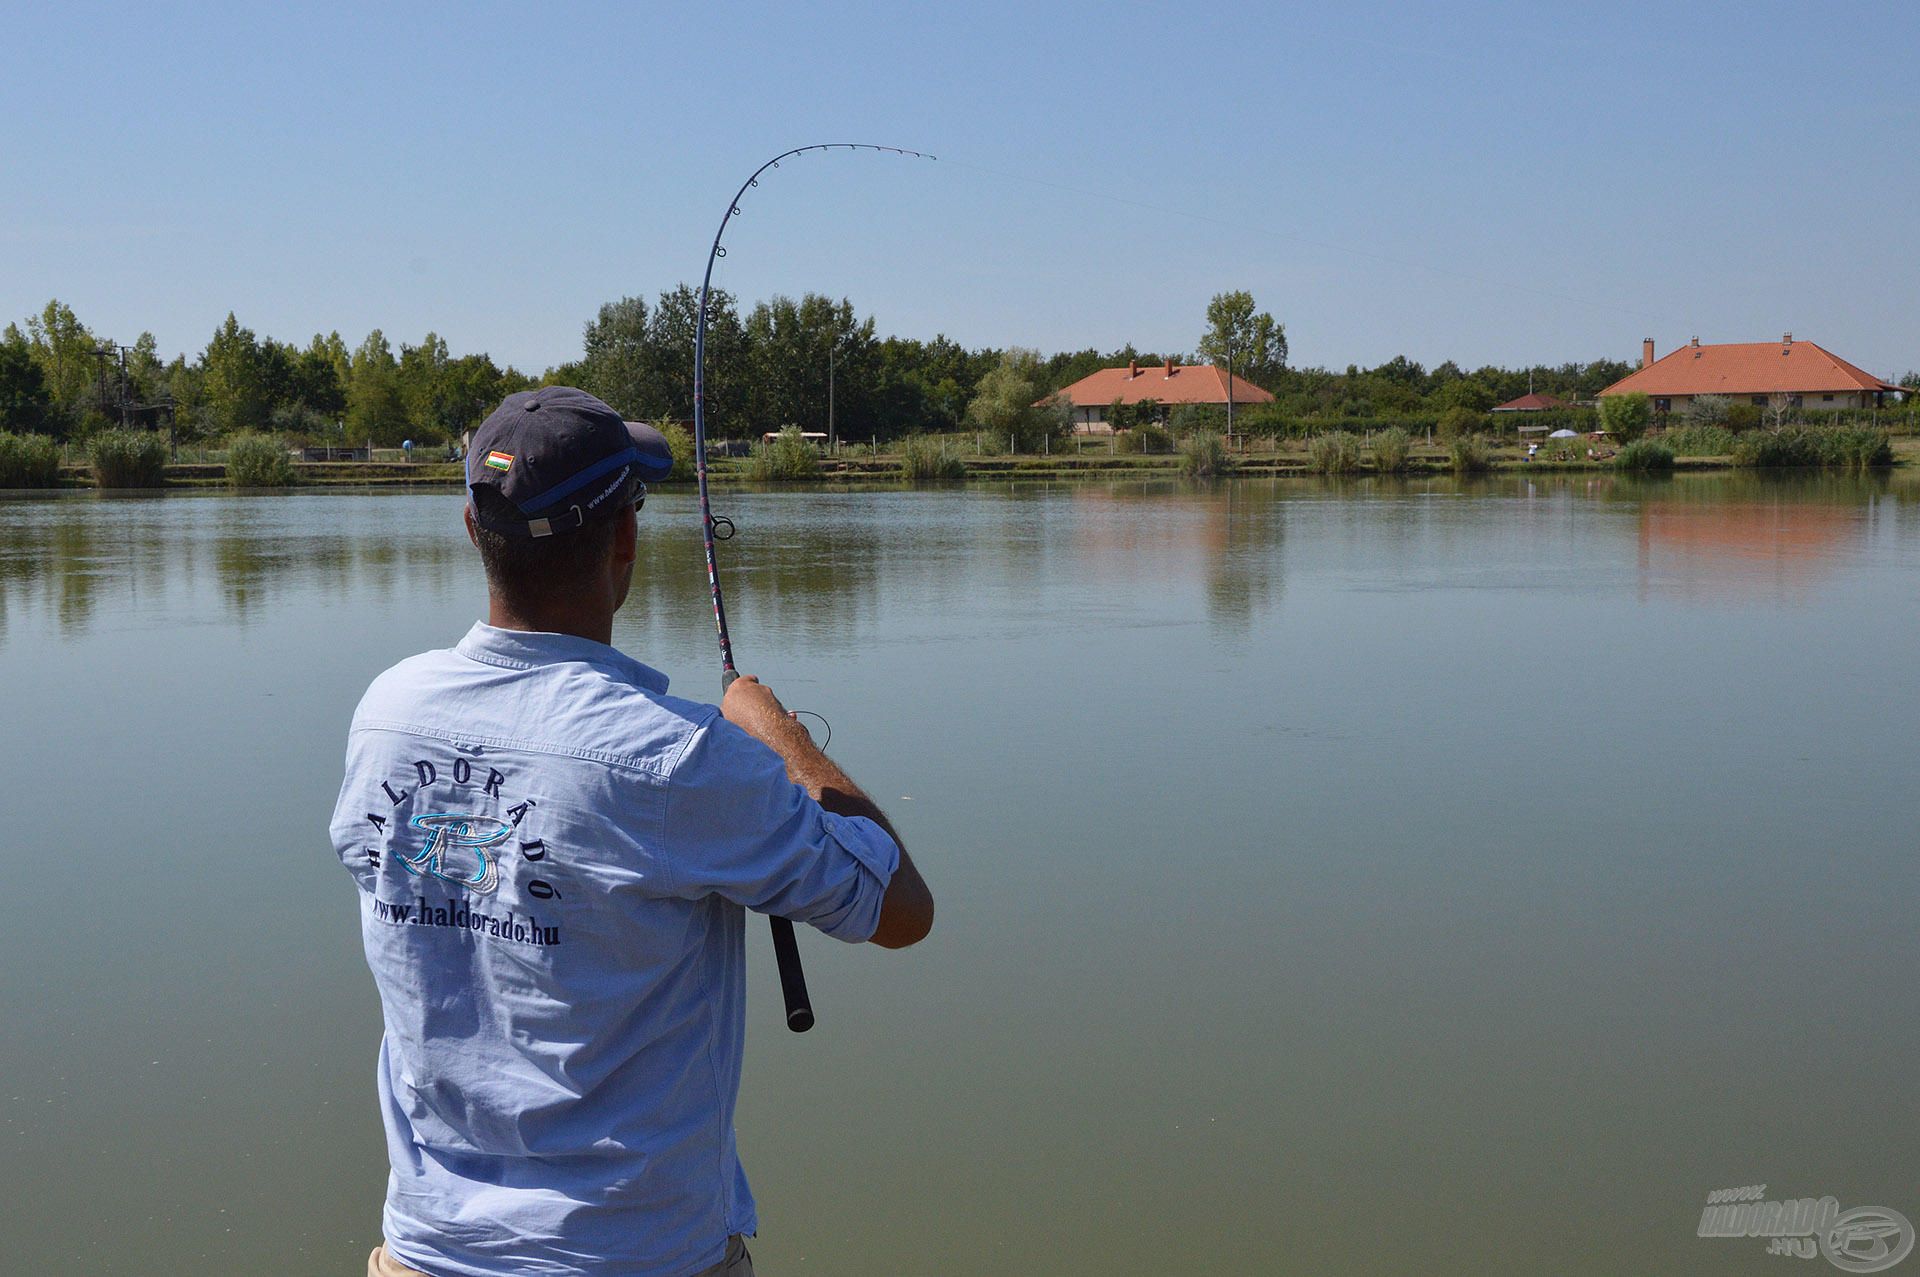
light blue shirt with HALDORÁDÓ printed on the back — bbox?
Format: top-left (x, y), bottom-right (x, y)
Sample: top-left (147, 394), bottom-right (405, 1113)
top-left (332, 624), bottom-right (900, 1277)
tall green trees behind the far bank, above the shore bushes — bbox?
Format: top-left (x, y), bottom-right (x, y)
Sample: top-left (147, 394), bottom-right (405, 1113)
top-left (0, 284), bottom-right (1766, 447)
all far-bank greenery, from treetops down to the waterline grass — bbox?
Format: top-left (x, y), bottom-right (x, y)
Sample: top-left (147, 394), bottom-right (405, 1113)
top-left (0, 284), bottom-right (1920, 490)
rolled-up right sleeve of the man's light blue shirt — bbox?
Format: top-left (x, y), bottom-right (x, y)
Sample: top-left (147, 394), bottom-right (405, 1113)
top-left (660, 716), bottom-right (900, 943)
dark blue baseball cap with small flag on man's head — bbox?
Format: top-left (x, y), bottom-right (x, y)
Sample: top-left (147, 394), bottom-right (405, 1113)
top-left (467, 386), bottom-right (674, 536)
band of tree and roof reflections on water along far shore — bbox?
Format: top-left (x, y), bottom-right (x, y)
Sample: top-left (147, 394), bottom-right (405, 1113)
top-left (15, 472), bottom-right (1920, 649)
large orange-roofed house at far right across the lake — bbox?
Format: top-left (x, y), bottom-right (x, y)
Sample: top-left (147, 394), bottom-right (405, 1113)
top-left (1599, 332), bottom-right (1901, 413)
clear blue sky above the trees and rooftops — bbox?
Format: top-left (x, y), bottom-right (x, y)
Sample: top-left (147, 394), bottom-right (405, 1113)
top-left (0, 0), bottom-right (1920, 374)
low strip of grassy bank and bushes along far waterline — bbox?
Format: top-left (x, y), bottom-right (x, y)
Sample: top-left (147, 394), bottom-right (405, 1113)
top-left (15, 426), bottom-right (1920, 492)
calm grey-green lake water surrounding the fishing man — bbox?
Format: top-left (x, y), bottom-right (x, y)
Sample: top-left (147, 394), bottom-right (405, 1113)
top-left (0, 476), bottom-right (1920, 1277)
